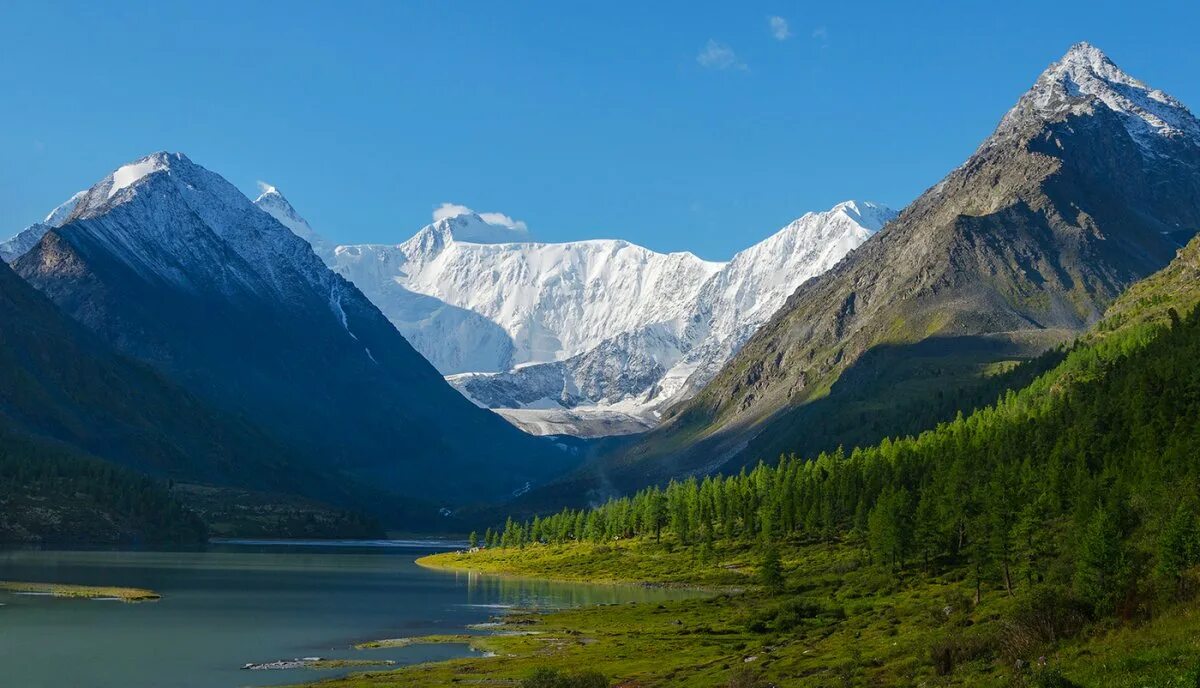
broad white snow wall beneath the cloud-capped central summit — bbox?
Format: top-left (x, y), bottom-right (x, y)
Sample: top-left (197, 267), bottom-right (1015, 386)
top-left (343, 208), bottom-right (720, 373)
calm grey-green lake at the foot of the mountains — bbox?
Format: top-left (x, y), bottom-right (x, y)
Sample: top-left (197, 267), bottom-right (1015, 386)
top-left (0, 542), bottom-right (690, 688)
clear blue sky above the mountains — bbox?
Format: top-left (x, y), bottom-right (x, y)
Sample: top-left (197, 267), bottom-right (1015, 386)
top-left (0, 0), bottom-right (1200, 259)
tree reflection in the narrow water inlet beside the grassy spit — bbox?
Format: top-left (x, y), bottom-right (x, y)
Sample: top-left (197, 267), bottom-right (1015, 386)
top-left (455, 572), bottom-right (696, 609)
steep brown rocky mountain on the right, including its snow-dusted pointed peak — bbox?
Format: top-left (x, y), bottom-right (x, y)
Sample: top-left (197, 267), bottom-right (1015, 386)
top-left (589, 43), bottom-right (1200, 484)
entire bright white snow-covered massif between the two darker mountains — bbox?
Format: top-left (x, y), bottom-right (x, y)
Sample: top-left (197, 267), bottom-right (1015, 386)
top-left (258, 189), bottom-right (894, 435)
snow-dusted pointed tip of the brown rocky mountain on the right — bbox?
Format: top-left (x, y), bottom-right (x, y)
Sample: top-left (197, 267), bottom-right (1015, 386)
top-left (985, 42), bottom-right (1200, 155)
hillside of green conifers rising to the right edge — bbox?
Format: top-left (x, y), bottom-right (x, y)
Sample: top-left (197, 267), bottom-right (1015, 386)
top-left (456, 240), bottom-right (1200, 671)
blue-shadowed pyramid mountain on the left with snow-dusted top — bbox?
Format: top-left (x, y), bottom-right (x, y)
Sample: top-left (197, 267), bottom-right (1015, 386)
top-left (13, 154), bottom-right (569, 502)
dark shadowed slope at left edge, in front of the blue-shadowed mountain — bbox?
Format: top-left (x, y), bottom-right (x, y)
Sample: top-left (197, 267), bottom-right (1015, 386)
top-left (0, 248), bottom-right (362, 543)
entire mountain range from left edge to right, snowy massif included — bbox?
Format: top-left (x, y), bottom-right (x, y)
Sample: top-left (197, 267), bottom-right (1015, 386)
top-left (0, 43), bottom-right (1200, 542)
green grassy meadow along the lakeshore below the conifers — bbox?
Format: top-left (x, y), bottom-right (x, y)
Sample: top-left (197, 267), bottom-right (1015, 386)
top-left (292, 542), bottom-right (1200, 688)
